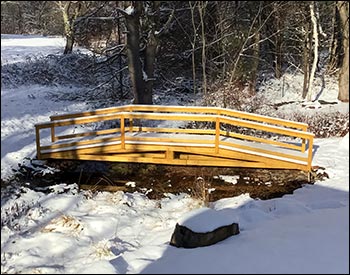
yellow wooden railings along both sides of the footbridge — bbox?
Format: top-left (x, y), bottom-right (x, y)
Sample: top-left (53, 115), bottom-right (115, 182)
top-left (35, 105), bottom-right (314, 169)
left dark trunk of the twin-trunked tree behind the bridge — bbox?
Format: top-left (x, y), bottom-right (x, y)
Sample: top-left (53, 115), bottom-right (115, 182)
top-left (125, 1), bottom-right (149, 104)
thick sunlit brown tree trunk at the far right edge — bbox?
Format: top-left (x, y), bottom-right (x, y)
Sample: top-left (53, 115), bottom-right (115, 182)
top-left (337, 1), bottom-right (349, 102)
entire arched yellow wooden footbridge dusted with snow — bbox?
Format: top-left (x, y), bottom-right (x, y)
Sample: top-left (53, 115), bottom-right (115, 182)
top-left (35, 105), bottom-right (314, 171)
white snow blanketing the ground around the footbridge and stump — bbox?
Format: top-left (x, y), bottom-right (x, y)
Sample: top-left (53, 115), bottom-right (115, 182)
top-left (1, 35), bottom-right (349, 274)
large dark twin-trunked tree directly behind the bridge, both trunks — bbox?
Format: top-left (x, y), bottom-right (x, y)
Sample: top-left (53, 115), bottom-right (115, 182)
top-left (119, 1), bottom-right (174, 104)
